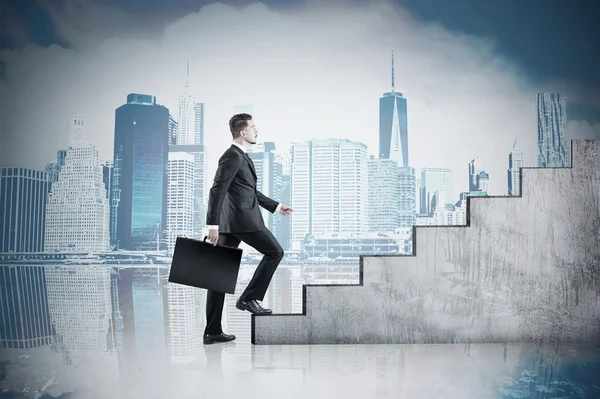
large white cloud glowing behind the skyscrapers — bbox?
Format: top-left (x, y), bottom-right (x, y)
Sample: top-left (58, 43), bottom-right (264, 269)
top-left (0, 2), bottom-right (598, 200)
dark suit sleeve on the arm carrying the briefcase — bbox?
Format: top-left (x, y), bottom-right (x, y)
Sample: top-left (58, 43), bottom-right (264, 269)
top-left (206, 151), bottom-right (244, 226)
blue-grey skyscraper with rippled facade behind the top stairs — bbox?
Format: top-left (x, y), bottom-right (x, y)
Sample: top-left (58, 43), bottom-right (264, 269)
top-left (537, 93), bottom-right (571, 168)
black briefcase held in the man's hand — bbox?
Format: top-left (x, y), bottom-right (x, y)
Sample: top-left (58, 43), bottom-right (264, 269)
top-left (169, 237), bottom-right (243, 294)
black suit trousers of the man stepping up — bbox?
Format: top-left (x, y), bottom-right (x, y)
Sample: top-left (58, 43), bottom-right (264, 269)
top-left (204, 227), bottom-right (283, 335)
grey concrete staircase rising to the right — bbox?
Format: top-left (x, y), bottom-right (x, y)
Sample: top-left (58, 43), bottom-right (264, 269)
top-left (252, 140), bottom-right (600, 345)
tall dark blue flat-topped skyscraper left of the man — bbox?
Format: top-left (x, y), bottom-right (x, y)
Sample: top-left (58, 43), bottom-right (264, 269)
top-left (111, 94), bottom-right (172, 250)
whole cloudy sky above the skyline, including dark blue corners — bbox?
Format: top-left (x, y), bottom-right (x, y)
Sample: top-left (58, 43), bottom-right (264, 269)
top-left (0, 0), bottom-right (600, 195)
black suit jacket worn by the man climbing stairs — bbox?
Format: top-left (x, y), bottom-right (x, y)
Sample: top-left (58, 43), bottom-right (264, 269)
top-left (206, 144), bottom-right (279, 233)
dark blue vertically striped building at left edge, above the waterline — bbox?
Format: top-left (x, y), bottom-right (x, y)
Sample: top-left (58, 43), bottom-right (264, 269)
top-left (0, 168), bottom-right (49, 252)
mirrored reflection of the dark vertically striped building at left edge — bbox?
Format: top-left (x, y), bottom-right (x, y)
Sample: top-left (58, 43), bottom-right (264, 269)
top-left (0, 265), bottom-right (52, 349)
